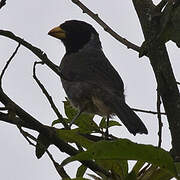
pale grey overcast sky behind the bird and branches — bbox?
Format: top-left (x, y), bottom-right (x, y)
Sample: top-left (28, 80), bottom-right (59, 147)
top-left (0, 0), bottom-right (180, 180)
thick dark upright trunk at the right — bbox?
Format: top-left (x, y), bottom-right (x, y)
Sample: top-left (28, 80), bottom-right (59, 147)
top-left (132, 0), bottom-right (180, 157)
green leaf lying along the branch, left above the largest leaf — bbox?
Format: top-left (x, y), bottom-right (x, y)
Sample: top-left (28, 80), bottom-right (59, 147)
top-left (56, 129), bottom-right (94, 149)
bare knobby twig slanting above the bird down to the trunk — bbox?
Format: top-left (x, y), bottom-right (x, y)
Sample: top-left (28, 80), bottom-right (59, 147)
top-left (71, 0), bottom-right (140, 52)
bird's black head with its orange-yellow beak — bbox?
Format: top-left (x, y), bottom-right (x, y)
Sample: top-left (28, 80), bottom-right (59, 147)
top-left (48, 20), bottom-right (101, 53)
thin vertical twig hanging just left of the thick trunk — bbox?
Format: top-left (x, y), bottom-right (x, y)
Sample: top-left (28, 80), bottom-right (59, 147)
top-left (157, 91), bottom-right (163, 147)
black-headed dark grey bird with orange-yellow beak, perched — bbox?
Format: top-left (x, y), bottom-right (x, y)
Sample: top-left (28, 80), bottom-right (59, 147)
top-left (48, 20), bottom-right (148, 135)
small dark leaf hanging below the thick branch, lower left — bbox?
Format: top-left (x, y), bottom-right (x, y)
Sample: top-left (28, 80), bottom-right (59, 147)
top-left (36, 134), bottom-right (50, 159)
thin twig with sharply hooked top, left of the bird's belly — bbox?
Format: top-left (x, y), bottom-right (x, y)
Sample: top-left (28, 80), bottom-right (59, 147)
top-left (33, 62), bottom-right (69, 129)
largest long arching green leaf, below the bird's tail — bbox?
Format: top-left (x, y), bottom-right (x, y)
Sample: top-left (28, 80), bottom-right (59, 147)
top-left (69, 139), bottom-right (176, 176)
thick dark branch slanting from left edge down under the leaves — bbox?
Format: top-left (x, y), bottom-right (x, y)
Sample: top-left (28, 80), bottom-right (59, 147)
top-left (0, 89), bottom-right (111, 177)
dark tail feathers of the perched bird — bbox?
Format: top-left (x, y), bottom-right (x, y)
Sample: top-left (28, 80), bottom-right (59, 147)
top-left (114, 101), bottom-right (148, 135)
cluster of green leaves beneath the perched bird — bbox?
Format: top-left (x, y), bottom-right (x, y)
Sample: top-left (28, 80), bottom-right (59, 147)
top-left (36, 100), bottom-right (180, 180)
